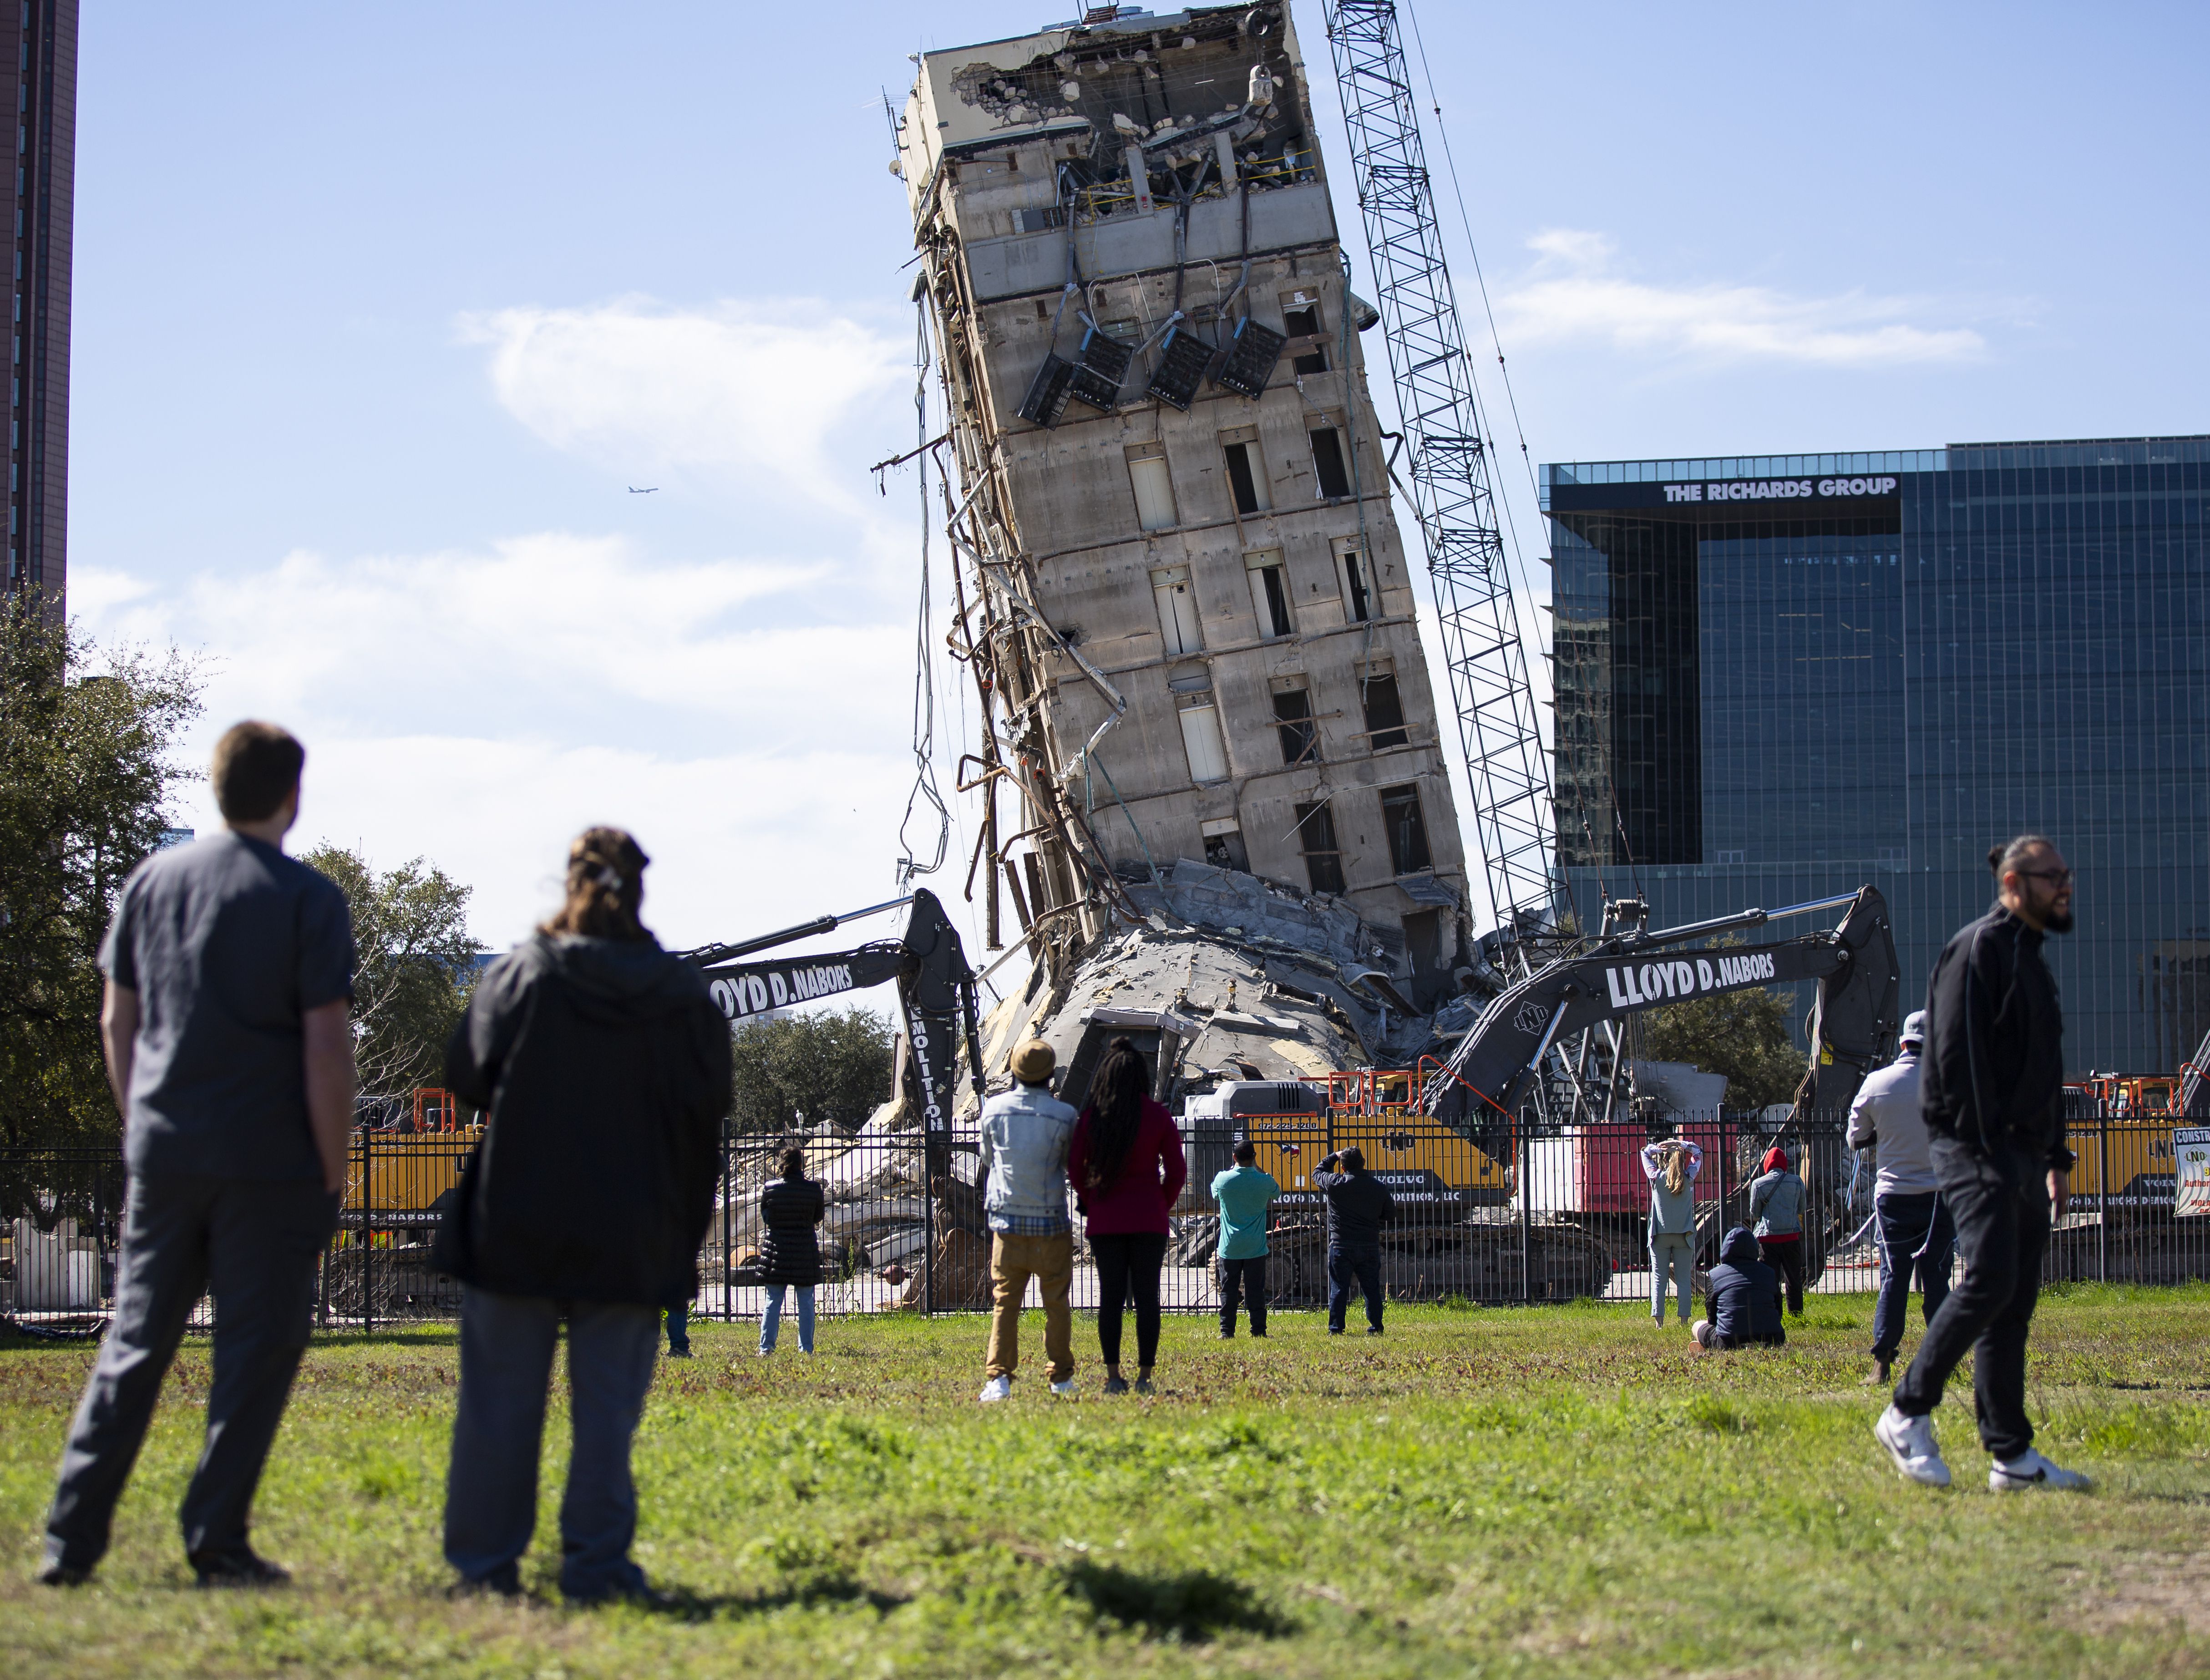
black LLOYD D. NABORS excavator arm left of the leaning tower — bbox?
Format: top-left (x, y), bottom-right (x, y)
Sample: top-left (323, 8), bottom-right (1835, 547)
top-left (681, 888), bottom-right (983, 1169)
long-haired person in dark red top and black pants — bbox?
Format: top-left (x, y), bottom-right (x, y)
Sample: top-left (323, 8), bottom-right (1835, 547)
top-left (1067, 1039), bottom-right (1189, 1395)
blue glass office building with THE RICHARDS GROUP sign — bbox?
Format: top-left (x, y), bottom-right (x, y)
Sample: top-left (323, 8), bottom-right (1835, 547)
top-left (1542, 438), bottom-right (2210, 1072)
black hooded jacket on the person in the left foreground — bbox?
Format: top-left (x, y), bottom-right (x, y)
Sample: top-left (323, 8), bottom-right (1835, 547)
top-left (436, 933), bottom-right (729, 1306)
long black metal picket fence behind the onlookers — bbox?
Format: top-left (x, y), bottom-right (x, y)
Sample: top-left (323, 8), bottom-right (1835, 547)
top-left (0, 1114), bottom-right (2210, 1335)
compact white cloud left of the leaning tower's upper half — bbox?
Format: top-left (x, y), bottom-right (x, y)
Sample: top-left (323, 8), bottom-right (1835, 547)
top-left (460, 299), bottom-right (913, 511)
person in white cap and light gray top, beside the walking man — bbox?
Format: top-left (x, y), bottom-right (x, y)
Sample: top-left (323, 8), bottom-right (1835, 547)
top-left (1850, 1010), bottom-right (1956, 1384)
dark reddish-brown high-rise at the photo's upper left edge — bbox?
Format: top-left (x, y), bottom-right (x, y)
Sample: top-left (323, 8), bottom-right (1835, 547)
top-left (0, 0), bottom-right (77, 617)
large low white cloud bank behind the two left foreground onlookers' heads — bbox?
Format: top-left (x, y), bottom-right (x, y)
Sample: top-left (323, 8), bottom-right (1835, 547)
top-left (71, 533), bottom-right (959, 946)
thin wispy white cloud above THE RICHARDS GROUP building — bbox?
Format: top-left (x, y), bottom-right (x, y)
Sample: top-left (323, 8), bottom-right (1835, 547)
top-left (1498, 228), bottom-right (1987, 367)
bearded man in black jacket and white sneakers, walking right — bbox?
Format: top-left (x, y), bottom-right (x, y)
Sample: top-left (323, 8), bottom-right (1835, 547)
top-left (1872, 833), bottom-right (2086, 1492)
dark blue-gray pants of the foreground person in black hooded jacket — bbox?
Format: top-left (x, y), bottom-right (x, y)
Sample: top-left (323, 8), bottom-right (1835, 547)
top-left (444, 1287), bottom-right (661, 1598)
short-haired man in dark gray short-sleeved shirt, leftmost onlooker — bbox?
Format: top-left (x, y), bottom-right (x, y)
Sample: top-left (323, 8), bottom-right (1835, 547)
top-left (40, 723), bottom-right (354, 1587)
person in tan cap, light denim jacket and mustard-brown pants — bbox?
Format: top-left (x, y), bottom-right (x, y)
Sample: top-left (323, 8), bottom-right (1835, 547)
top-left (977, 1039), bottom-right (1074, 1406)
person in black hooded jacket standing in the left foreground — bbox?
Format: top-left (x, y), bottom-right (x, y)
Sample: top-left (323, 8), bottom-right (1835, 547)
top-left (436, 829), bottom-right (729, 1598)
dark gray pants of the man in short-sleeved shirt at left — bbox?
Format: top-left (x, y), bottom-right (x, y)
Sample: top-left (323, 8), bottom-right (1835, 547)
top-left (46, 1174), bottom-right (338, 1569)
